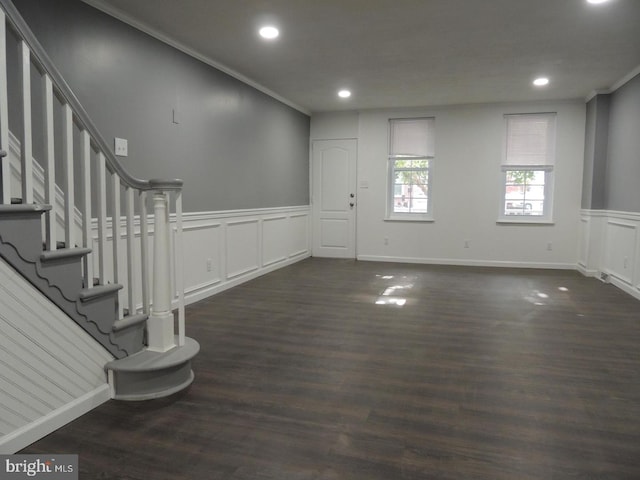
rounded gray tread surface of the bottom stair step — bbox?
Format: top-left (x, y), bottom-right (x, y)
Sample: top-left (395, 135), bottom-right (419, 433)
top-left (105, 337), bottom-right (200, 372)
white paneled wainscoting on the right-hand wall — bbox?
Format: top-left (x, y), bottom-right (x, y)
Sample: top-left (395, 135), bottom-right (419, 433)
top-left (578, 210), bottom-right (640, 299)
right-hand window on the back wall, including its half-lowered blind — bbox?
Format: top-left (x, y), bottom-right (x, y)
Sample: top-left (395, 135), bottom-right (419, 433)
top-left (500, 113), bottom-right (556, 223)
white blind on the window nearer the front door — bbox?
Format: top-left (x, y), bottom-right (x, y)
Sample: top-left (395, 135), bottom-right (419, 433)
top-left (389, 118), bottom-right (435, 158)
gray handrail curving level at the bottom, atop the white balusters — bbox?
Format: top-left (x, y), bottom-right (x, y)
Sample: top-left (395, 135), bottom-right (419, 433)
top-left (0, 0), bottom-right (182, 190)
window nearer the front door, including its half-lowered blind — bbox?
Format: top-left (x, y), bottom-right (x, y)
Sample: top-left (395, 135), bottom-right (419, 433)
top-left (387, 118), bottom-right (435, 220)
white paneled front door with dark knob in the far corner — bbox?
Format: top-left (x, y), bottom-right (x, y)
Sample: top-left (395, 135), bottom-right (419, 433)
top-left (312, 140), bottom-right (357, 258)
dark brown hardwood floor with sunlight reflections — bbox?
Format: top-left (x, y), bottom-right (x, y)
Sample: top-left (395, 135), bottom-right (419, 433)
top-left (22, 259), bottom-right (640, 480)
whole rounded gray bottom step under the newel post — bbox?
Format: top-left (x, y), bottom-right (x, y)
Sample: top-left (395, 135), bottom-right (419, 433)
top-left (105, 337), bottom-right (200, 401)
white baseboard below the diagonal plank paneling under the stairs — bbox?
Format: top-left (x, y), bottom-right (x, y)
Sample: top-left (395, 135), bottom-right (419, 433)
top-left (0, 383), bottom-right (111, 454)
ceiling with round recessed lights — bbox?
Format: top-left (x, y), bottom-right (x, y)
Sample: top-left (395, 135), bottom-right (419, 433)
top-left (85, 0), bottom-right (640, 113)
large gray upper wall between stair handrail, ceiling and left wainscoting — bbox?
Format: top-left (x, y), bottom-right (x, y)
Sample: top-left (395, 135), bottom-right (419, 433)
top-left (14, 0), bottom-right (310, 211)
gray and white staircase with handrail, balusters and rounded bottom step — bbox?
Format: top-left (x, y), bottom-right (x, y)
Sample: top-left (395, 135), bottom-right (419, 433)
top-left (0, 0), bottom-right (199, 400)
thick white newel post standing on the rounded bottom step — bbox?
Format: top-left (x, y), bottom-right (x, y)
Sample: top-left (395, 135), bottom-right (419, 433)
top-left (147, 192), bottom-right (176, 352)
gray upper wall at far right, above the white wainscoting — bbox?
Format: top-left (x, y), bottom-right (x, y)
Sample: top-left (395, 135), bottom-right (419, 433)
top-left (605, 75), bottom-right (640, 212)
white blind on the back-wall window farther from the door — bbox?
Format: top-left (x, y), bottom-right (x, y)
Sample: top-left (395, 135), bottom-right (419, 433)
top-left (503, 113), bottom-right (556, 169)
